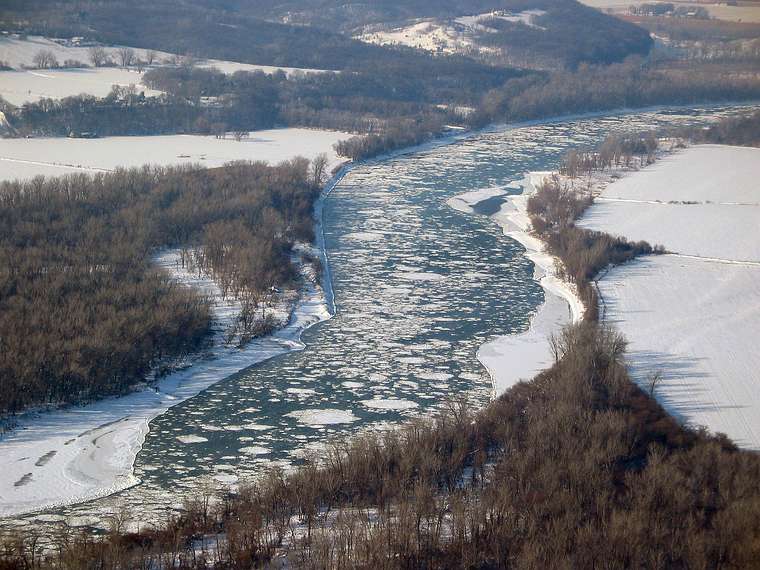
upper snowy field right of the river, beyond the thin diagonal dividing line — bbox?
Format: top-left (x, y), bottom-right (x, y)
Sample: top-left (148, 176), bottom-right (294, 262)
top-left (579, 145), bottom-right (760, 261)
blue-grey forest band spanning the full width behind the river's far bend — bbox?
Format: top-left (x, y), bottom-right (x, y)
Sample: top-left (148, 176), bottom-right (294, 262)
top-left (5, 51), bottom-right (760, 160)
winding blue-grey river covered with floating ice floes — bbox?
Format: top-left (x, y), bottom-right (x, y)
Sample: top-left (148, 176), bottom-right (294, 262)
top-left (4, 103), bottom-right (756, 526)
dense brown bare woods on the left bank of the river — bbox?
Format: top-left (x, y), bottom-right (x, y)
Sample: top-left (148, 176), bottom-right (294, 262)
top-left (0, 159), bottom-right (318, 415)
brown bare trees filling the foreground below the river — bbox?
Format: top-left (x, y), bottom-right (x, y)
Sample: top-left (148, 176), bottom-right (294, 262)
top-left (5, 322), bottom-right (760, 570)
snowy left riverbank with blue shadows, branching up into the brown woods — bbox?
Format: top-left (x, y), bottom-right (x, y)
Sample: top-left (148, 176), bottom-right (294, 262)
top-left (0, 246), bottom-right (331, 516)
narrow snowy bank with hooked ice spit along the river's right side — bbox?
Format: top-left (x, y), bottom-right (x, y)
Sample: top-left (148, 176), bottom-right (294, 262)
top-left (448, 172), bottom-right (584, 396)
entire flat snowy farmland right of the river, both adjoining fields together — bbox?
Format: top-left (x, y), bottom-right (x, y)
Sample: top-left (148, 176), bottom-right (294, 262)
top-left (581, 145), bottom-right (760, 450)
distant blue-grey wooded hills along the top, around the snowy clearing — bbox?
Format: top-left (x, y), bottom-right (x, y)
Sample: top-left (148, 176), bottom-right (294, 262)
top-left (0, 0), bottom-right (651, 69)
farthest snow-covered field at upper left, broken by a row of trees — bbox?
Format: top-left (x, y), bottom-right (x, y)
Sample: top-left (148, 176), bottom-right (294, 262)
top-left (0, 36), bottom-right (321, 105)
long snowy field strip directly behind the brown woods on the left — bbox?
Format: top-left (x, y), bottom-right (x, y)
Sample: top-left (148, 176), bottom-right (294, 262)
top-left (0, 129), bottom-right (351, 181)
